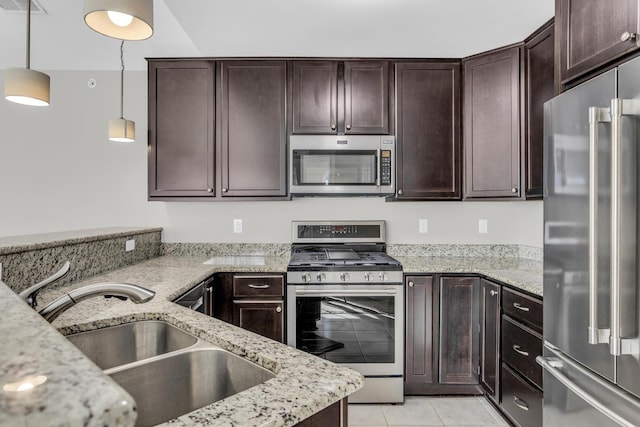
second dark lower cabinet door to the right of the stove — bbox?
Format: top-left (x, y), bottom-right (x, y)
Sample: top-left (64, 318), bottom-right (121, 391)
top-left (439, 277), bottom-right (480, 384)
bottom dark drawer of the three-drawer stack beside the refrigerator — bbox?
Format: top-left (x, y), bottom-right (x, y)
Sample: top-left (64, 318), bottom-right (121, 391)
top-left (500, 364), bottom-right (542, 427)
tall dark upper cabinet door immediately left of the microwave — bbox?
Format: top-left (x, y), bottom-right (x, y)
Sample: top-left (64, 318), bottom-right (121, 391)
top-left (220, 61), bottom-right (287, 197)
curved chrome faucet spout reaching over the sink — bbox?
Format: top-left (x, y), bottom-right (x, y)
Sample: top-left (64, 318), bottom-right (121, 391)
top-left (38, 283), bottom-right (156, 322)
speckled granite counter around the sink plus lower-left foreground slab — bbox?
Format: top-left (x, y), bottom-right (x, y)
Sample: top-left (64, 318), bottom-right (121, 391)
top-left (0, 256), bottom-right (364, 426)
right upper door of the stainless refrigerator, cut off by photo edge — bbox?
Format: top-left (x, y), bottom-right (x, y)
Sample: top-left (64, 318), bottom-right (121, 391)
top-left (616, 55), bottom-right (640, 396)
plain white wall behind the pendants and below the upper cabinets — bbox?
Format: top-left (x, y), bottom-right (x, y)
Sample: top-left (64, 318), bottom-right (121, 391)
top-left (0, 71), bottom-right (542, 247)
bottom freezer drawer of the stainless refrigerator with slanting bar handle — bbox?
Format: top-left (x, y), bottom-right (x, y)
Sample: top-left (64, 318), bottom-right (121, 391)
top-left (539, 345), bottom-right (640, 427)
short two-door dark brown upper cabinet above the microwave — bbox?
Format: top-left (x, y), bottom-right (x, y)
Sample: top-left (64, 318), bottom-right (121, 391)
top-left (291, 61), bottom-right (389, 135)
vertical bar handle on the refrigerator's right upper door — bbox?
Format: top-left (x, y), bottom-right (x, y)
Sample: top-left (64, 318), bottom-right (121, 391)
top-left (609, 98), bottom-right (640, 356)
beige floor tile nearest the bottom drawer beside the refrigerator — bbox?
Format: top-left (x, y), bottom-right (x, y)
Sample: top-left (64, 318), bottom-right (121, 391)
top-left (430, 397), bottom-right (498, 426)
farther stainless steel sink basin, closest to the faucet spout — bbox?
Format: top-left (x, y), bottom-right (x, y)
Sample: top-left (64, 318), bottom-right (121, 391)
top-left (67, 320), bottom-right (198, 370)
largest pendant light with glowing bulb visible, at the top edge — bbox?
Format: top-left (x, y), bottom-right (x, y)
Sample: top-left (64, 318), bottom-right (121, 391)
top-left (84, 0), bottom-right (153, 40)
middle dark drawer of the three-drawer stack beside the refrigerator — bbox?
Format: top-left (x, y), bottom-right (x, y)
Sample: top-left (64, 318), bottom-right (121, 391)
top-left (502, 316), bottom-right (542, 388)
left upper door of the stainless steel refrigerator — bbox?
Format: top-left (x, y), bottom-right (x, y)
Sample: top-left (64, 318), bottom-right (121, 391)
top-left (544, 70), bottom-right (616, 382)
